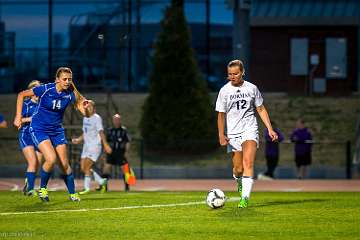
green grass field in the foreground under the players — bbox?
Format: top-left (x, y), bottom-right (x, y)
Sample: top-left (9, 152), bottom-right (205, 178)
top-left (0, 191), bottom-right (360, 240)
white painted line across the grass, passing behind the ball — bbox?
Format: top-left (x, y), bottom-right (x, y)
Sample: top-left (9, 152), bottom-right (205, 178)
top-left (0, 197), bottom-right (240, 216)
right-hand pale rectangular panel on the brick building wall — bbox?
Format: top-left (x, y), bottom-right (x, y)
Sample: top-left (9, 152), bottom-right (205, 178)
top-left (326, 38), bottom-right (347, 78)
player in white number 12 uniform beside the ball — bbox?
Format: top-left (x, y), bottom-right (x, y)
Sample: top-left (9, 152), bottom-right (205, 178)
top-left (216, 60), bottom-right (278, 208)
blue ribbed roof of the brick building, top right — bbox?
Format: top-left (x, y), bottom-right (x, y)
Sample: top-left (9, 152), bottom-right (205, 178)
top-left (250, 0), bottom-right (360, 26)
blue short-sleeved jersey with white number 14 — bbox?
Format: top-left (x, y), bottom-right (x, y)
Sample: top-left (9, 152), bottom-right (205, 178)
top-left (31, 83), bottom-right (75, 132)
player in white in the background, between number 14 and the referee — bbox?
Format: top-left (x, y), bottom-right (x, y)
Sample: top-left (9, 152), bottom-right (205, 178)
top-left (72, 100), bottom-right (112, 194)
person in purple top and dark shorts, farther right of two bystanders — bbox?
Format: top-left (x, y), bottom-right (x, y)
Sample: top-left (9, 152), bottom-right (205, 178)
top-left (290, 119), bottom-right (312, 179)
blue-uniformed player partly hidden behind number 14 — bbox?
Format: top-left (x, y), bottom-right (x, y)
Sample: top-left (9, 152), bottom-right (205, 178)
top-left (19, 80), bottom-right (42, 196)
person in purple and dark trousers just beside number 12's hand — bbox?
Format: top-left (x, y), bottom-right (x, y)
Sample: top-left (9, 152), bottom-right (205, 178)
top-left (258, 121), bottom-right (284, 180)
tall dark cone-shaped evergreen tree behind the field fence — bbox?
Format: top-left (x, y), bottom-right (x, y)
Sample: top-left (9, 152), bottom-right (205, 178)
top-left (140, 0), bottom-right (217, 150)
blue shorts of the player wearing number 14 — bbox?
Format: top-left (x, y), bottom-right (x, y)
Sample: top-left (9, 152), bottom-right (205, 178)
top-left (29, 127), bottom-right (67, 147)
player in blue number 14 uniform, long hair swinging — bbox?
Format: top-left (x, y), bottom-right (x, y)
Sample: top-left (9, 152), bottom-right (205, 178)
top-left (14, 67), bottom-right (87, 202)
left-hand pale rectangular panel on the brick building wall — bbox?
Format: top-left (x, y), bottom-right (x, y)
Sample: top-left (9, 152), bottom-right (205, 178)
top-left (290, 38), bottom-right (309, 76)
